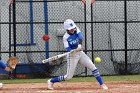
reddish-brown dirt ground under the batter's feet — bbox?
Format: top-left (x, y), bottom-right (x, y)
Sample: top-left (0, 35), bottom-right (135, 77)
top-left (0, 81), bottom-right (140, 93)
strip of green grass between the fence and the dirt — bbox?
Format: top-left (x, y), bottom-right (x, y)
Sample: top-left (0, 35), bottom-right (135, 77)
top-left (1, 75), bottom-right (140, 84)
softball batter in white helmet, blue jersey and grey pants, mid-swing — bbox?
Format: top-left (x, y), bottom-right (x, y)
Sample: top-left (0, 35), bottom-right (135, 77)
top-left (48, 19), bottom-right (108, 90)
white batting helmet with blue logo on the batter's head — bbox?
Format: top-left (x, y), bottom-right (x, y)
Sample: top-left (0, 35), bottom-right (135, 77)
top-left (64, 19), bottom-right (76, 30)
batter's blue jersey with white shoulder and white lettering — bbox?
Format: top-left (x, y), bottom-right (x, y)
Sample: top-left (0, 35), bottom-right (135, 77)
top-left (63, 27), bottom-right (83, 52)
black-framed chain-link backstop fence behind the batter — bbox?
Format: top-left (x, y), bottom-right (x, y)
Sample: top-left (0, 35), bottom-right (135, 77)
top-left (0, 0), bottom-right (140, 78)
